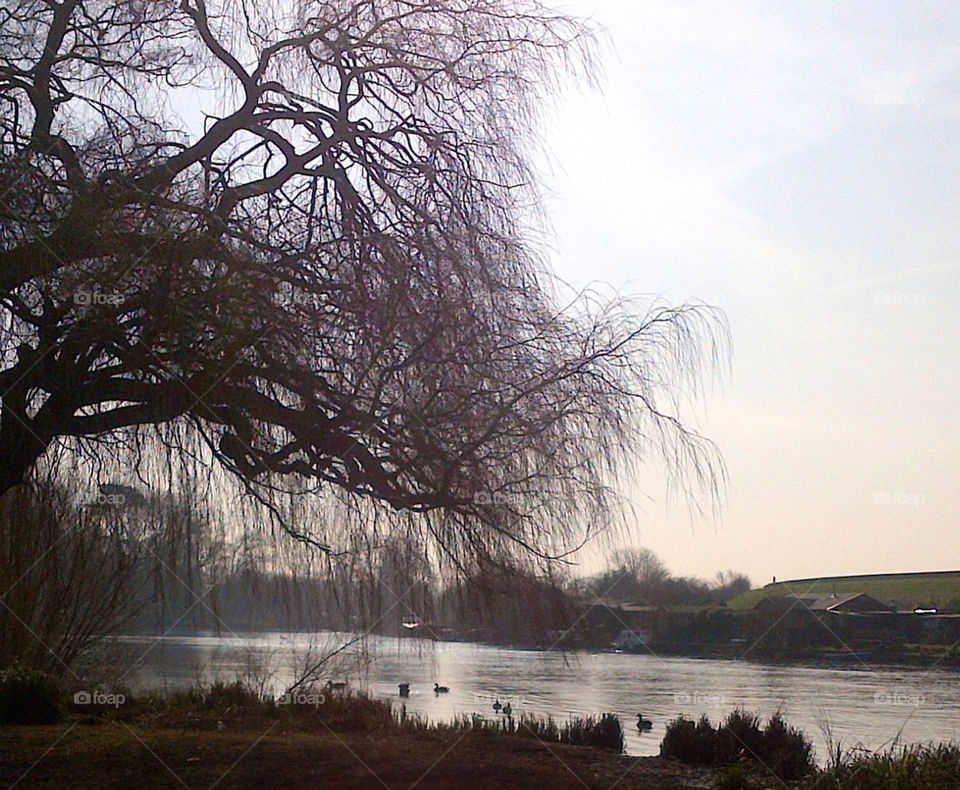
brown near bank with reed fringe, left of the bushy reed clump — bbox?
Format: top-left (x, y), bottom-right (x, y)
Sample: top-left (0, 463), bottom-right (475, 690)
top-left (0, 674), bottom-right (713, 790)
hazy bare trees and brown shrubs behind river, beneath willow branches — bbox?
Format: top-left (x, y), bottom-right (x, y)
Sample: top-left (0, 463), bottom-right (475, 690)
top-left (0, 468), bottom-right (750, 672)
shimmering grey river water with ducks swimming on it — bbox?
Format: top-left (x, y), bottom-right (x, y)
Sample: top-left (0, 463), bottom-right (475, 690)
top-left (122, 633), bottom-right (960, 761)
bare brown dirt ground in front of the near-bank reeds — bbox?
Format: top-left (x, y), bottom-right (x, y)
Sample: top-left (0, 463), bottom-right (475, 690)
top-left (0, 722), bottom-right (713, 790)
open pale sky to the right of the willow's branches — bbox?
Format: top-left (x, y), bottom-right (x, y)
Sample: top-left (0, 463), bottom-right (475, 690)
top-left (546, 0), bottom-right (960, 583)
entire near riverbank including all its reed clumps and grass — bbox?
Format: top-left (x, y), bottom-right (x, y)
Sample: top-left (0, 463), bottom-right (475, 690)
top-left (0, 670), bottom-right (960, 790)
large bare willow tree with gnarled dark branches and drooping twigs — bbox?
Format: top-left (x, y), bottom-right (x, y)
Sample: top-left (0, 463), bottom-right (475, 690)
top-left (0, 0), bottom-right (725, 561)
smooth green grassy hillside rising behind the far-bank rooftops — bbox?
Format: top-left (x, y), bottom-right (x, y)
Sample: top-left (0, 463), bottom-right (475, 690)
top-left (728, 571), bottom-right (960, 611)
